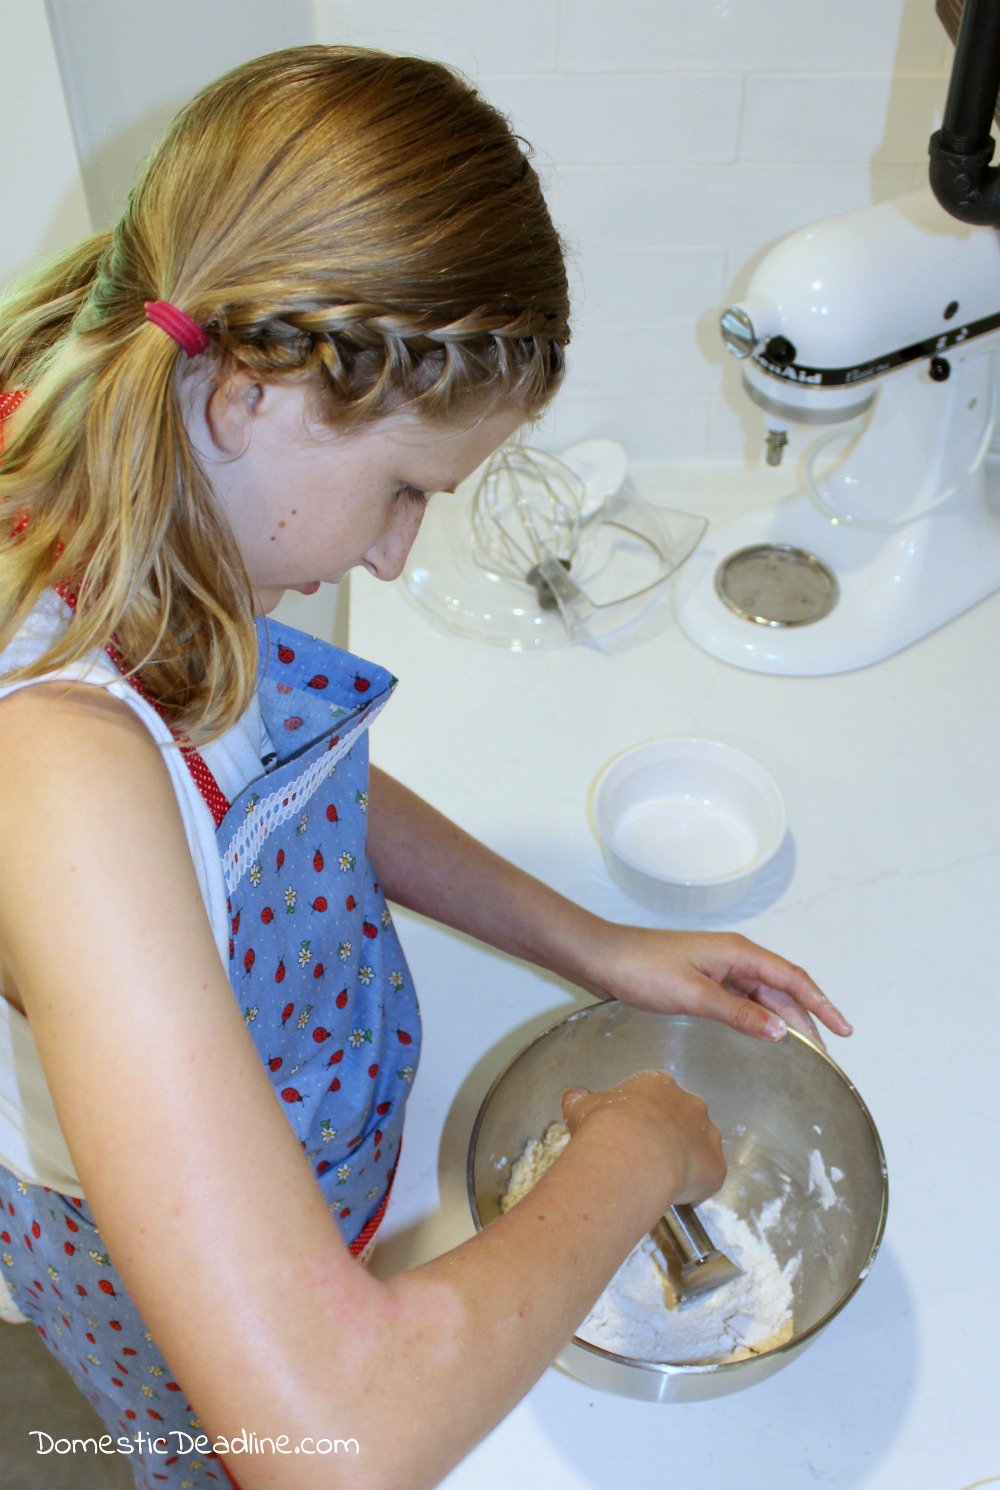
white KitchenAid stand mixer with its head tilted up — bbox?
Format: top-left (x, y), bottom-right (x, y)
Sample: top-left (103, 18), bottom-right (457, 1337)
top-left (678, 191), bottom-right (1000, 675)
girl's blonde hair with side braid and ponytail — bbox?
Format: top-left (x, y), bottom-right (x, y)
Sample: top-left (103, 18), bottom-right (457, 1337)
top-left (0, 46), bottom-right (569, 742)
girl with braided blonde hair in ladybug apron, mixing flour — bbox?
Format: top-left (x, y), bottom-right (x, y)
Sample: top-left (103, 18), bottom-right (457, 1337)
top-left (0, 48), bottom-right (848, 1490)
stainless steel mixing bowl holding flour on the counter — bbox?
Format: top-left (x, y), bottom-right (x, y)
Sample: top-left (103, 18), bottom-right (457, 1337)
top-left (468, 1003), bottom-right (888, 1402)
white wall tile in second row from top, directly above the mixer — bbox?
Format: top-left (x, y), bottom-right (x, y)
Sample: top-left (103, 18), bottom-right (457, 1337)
top-left (739, 73), bottom-right (948, 165)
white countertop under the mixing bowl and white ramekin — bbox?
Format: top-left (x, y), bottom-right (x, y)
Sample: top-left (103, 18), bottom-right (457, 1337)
top-left (350, 466), bottom-right (1000, 1490)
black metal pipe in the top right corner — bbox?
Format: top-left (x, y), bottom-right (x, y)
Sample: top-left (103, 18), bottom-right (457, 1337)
top-left (930, 0), bottom-right (1000, 228)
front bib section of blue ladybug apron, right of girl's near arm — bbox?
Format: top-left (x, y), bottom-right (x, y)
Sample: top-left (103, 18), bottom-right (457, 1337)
top-left (226, 627), bottom-right (420, 1244)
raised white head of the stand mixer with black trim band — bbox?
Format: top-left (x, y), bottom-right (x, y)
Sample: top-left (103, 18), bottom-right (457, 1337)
top-left (721, 191), bottom-right (1000, 465)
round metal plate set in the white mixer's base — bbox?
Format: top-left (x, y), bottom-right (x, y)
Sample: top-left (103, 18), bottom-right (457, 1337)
top-left (715, 544), bottom-right (841, 626)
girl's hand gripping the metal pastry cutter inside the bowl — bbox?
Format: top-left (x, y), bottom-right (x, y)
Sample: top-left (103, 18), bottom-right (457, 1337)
top-left (562, 1071), bottom-right (726, 1216)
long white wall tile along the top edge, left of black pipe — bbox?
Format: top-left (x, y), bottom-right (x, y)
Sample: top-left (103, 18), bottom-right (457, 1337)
top-left (559, 0), bottom-right (948, 73)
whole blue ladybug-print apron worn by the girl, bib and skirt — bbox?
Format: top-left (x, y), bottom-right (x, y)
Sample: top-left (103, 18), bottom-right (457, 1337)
top-left (0, 624), bottom-right (420, 1490)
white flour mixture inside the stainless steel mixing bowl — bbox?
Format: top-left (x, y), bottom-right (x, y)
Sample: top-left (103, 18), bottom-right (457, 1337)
top-left (501, 1122), bottom-right (800, 1366)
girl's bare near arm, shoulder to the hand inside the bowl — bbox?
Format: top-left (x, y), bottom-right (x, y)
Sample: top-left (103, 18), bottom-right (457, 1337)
top-left (0, 685), bottom-right (724, 1490)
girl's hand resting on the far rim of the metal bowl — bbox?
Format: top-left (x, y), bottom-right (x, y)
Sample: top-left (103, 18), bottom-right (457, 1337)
top-left (584, 924), bottom-right (851, 1049)
